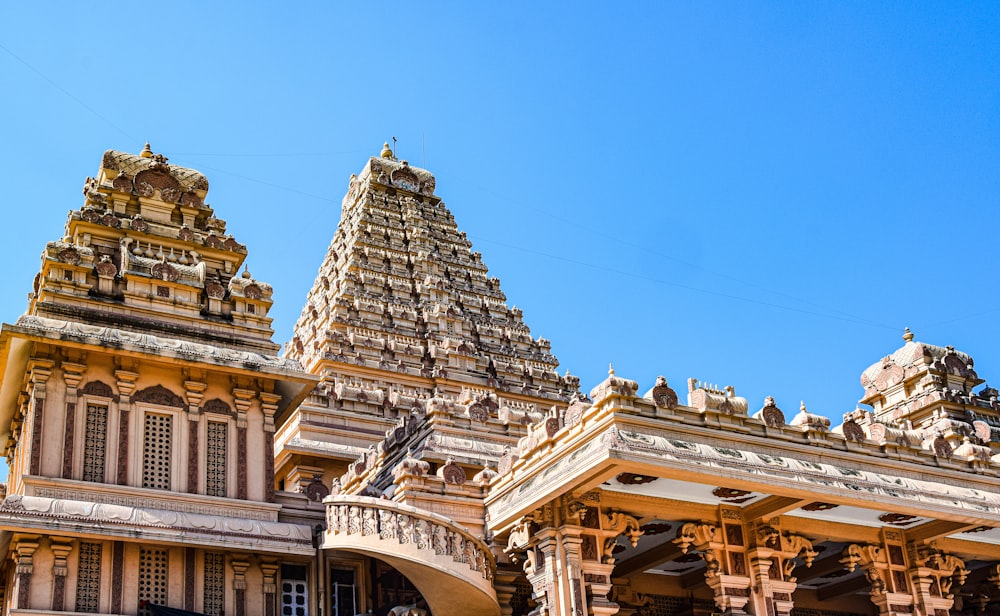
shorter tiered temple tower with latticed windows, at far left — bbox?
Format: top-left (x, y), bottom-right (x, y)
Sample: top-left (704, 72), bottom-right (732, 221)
top-left (0, 144), bottom-right (315, 616)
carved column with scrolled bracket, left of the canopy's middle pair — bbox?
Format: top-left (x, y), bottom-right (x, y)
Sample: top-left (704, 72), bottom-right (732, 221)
top-left (674, 522), bottom-right (750, 616)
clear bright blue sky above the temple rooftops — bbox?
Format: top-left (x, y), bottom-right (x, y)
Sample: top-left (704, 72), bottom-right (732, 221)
top-left (0, 2), bottom-right (1000, 434)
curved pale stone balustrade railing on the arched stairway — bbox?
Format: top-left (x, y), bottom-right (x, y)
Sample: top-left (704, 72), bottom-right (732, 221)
top-left (323, 496), bottom-right (496, 584)
